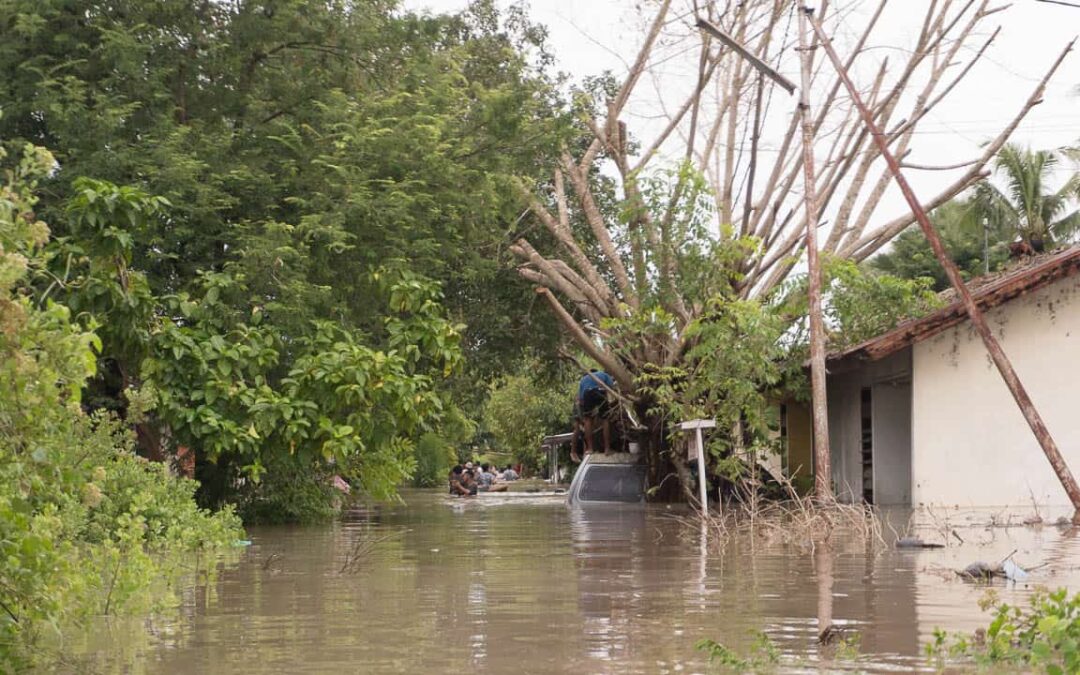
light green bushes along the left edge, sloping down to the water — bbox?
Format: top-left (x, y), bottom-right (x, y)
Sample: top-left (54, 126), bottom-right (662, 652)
top-left (0, 139), bottom-right (240, 671)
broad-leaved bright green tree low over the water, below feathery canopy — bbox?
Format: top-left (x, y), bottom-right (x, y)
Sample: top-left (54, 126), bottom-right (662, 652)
top-left (144, 265), bottom-right (461, 514)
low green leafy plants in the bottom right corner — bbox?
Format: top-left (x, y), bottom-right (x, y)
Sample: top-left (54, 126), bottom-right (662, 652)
top-left (927, 589), bottom-right (1080, 675)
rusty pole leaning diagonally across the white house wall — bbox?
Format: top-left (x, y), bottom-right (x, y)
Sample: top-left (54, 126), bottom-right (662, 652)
top-left (799, 6), bottom-right (1080, 524)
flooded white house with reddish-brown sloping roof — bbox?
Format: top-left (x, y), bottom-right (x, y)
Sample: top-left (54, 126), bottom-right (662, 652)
top-left (781, 247), bottom-right (1080, 507)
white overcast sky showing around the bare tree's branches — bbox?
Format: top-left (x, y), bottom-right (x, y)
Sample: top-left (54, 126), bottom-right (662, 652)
top-left (404, 0), bottom-right (1080, 228)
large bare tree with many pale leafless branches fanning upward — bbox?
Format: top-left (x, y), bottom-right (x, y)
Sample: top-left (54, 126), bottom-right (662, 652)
top-left (512, 0), bottom-right (1067, 496)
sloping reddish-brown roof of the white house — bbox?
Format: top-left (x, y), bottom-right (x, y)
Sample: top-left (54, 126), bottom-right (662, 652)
top-left (828, 246), bottom-right (1080, 363)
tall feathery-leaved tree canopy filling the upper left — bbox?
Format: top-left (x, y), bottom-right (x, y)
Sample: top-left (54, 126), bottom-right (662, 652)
top-left (0, 0), bottom-right (561, 349)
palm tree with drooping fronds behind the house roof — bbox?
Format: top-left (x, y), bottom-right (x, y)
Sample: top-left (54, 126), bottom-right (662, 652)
top-left (968, 145), bottom-right (1080, 251)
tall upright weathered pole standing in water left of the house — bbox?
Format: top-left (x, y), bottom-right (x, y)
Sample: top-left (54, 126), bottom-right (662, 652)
top-left (799, 5), bottom-right (833, 500)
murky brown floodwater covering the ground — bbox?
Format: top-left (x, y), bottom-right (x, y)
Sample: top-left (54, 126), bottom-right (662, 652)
top-left (69, 491), bottom-right (1080, 675)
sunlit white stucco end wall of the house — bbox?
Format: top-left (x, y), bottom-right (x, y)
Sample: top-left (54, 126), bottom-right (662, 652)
top-left (912, 276), bottom-right (1080, 507)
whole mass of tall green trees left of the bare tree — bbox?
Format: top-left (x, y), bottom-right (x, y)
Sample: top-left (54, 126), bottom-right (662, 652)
top-left (0, 0), bottom-right (563, 519)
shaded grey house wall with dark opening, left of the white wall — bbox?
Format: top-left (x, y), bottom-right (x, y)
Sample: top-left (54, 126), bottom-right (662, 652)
top-left (827, 350), bottom-right (912, 503)
